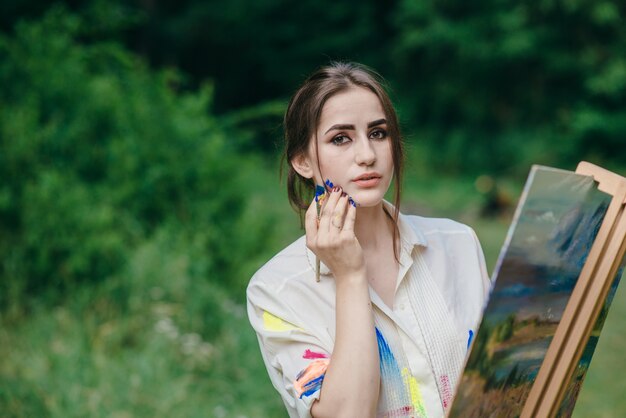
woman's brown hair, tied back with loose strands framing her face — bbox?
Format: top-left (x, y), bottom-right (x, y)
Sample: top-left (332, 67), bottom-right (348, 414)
top-left (283, 62), bottom-right (404, 257)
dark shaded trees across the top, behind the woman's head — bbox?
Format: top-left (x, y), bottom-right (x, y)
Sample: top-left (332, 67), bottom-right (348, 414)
top-left (0, 0), bottom-right (626, 177)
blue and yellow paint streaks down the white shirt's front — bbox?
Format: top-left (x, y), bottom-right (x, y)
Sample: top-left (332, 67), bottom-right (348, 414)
top-left (376, 328), bottom-right (426, 418)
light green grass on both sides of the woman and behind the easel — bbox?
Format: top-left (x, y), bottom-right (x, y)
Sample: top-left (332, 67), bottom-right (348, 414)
top-left (0, 162), bottom-right (626, 418)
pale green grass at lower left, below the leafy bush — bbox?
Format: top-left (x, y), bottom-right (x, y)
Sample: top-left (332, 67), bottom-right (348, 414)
top-left (0, 240), bottom-right (282, 417)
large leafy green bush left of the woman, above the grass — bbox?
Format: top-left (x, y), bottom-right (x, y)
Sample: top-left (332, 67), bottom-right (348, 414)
top-left (0, 9), bottom-right (270, 307)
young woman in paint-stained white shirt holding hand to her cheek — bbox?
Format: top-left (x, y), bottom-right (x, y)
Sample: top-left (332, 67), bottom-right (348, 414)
top-left (248, 63), bottom-right (489, 417)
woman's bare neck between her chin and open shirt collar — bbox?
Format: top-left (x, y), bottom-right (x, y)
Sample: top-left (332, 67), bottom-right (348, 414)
top-left (354, 202), bottom-right (393, 251)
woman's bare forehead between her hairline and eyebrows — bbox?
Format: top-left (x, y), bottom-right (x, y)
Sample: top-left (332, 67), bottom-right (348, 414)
top-left (319, 87), bottom-right (385, 128)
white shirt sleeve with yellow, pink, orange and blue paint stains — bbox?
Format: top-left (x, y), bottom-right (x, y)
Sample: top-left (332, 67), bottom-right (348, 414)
top-left (247, 280), bottom-right (330, 418)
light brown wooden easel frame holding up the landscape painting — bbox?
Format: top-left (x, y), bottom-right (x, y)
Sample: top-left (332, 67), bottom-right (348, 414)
top-left (521, 161), bottom-right (626, 418)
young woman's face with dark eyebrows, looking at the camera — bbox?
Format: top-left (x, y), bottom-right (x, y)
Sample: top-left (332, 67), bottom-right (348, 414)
top-left (308, 87), bottom-right (393, 207)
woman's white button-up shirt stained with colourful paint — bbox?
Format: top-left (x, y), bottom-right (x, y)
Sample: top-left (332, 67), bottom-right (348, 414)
top-left (247, 209), bottom-right (490, 418)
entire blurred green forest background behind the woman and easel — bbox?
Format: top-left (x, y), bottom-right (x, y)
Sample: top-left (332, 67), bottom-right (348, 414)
top-left (0, 0), bottom-right (626, 418)
